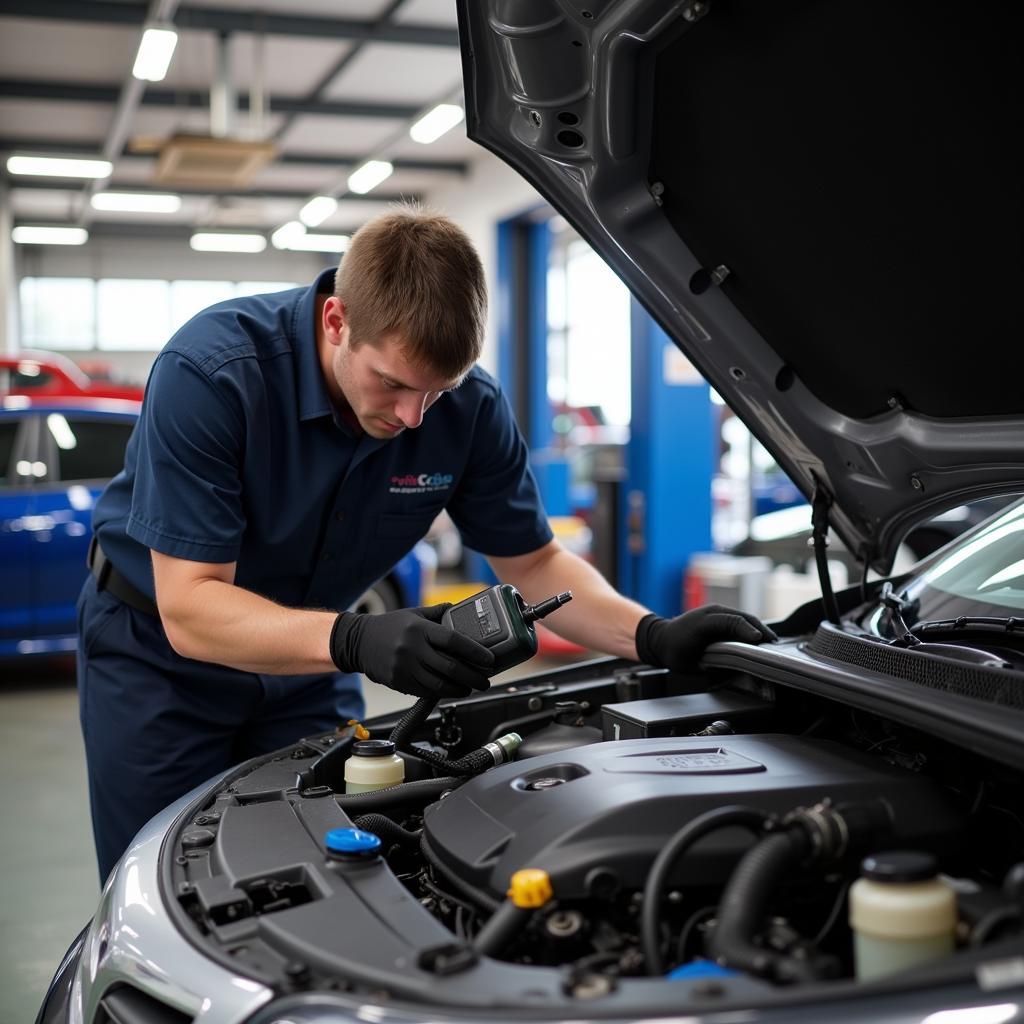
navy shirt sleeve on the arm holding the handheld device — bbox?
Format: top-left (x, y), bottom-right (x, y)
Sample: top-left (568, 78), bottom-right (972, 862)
top-left (126, 351), bottom-right (246, 563)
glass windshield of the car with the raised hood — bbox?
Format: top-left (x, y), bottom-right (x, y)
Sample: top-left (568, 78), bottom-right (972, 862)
top-left (870, 501), bottom-right (1024, 636)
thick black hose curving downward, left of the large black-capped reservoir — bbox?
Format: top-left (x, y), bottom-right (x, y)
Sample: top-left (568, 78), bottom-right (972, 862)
top-left (709, 828), bottom-right (810, 980)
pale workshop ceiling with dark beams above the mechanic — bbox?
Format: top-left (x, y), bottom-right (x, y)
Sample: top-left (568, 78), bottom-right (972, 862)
top-left (0, 0), bottom-right (471, 243)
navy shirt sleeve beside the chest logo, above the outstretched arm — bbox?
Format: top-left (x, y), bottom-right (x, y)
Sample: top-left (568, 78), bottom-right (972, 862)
top-left (447, 385), bottom-right (554, 558)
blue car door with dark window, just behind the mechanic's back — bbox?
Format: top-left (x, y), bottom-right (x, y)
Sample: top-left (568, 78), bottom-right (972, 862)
top-left (34, 410), bottom-right (135, 647)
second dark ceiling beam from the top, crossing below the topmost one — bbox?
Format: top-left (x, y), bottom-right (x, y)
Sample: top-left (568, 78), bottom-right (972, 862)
top-left (0, 78), bottom-right (422, 121)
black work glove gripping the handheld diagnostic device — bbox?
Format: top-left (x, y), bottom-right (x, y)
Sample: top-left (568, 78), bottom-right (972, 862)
top-left (331, 604), bottom-right (495, 697)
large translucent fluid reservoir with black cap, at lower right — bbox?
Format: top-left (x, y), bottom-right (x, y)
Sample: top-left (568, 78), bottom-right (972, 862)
top-left (850, 851), bottom-right (956, 981)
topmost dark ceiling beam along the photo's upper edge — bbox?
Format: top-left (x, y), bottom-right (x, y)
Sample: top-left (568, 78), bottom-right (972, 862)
top-left (0, 0), bottom-right (459, 47)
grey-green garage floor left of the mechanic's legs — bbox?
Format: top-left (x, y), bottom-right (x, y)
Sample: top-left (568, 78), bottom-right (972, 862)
top-left (0, 658), bottom-right (585, 1024)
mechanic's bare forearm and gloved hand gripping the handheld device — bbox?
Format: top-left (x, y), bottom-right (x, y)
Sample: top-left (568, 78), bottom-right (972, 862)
top-left (151, 550), bottom-right (494, 697)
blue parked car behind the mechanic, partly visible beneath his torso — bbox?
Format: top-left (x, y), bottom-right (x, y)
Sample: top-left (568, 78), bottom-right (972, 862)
top-left (0, 395), bottom-right (428, 657)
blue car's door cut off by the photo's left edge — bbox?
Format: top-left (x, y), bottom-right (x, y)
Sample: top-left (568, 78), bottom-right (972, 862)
top-left (0, 413), bottom-right (38, 655)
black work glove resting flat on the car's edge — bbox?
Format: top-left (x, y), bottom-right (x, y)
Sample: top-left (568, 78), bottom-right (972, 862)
top-left (636, 604), bottom-right (778, 672)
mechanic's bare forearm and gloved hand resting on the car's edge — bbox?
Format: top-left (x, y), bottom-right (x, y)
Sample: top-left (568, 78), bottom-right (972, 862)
top-left (487, 541), bottom-right (776, 672)
